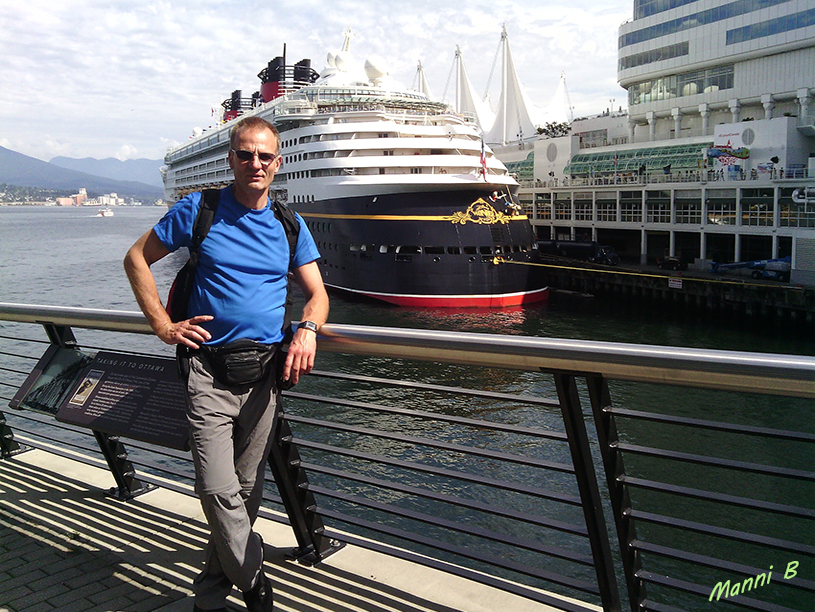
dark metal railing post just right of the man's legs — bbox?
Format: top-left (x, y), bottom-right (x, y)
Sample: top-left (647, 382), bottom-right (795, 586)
top-left (269, 396), bottom-right (344, 565)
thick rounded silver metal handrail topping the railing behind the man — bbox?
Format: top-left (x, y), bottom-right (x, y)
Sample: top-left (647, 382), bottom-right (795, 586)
top-left (0, 303), bottom-right (815, 398)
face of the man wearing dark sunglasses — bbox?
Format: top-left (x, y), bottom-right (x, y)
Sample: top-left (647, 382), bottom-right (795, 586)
top-left (229, 128), bottom-right (280, 193)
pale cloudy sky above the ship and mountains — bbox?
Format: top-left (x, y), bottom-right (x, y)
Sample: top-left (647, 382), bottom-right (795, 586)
top-left (0, 0), bottom-right (633, 161)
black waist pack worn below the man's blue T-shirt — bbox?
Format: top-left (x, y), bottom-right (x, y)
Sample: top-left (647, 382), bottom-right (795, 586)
top-left (201, 340), bottom-right (278, 386)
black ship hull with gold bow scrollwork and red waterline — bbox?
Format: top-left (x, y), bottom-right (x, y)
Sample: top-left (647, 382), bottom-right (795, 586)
top-left (295, 186), bottom-right (548, 307)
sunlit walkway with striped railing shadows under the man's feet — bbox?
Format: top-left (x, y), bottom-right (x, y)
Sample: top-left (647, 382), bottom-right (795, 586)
top-left (0, 450), bottom-right (592, 612)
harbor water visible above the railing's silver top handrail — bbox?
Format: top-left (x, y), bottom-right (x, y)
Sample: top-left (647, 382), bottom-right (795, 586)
top-left (0, 206), bottom-right (815, 355)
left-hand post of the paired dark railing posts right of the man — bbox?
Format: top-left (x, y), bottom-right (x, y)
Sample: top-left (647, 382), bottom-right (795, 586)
top-left (554, 372), bottom-right (621, 612)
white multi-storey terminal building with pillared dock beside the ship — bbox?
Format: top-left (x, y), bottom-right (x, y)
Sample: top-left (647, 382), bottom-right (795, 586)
top-left (489, 0), bottom-right (815, 284)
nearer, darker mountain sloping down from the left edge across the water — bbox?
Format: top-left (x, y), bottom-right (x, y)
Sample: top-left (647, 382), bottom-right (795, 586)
top-left (0, 147), bottom-right (164, 200)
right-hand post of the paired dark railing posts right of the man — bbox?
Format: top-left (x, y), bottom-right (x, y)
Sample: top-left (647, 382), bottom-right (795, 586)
top-left (586, 374), bottom-right (646, 612)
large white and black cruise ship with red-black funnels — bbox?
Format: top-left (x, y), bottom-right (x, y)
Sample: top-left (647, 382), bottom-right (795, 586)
top-left (163, 30), bottom-right (548, 307)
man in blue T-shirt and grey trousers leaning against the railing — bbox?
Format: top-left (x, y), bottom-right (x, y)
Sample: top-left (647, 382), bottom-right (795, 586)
top-left (124, 117), bottom-right (328, 612)
